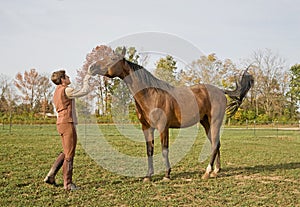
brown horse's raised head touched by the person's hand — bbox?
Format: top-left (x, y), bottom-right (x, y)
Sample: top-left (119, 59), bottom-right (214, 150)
top-left (89, 47), bottom-right (126, 78)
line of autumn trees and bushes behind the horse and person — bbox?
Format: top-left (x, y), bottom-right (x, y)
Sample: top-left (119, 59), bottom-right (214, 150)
top-left (0, 46), bottom-right (300, 123)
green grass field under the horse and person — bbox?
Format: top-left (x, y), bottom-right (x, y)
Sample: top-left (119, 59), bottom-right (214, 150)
top-left (0, 125), bottom-right (300, 206)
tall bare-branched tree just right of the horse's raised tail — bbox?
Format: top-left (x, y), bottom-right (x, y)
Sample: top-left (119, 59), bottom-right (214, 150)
top-left (250, 49), bottom-right (288, 118)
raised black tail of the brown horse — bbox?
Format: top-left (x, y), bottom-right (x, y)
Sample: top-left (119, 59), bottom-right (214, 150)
top-left (224, 66), bottom-right (254, 117)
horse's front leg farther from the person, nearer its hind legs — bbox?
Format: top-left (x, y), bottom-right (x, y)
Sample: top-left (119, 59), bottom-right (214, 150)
top-left (160, 128), bottom-right (171, 180)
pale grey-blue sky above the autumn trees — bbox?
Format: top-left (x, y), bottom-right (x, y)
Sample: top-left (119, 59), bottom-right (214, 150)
top-left (0, 0), bottom-right (300, 77)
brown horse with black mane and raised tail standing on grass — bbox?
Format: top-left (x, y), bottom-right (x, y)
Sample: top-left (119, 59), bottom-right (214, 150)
top-left (88, 46), bottom-right (254, 182)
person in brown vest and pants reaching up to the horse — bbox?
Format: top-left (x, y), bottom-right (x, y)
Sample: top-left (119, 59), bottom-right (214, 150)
top-left (44, 70), bottom-right (91, 190)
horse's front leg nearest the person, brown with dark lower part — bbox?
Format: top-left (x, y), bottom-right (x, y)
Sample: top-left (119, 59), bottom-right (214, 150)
top-left (142, 126), bottom-right (154, 182)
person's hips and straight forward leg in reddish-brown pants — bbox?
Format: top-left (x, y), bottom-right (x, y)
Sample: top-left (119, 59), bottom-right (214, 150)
top-left (57, 123), bottom-right (77, 189)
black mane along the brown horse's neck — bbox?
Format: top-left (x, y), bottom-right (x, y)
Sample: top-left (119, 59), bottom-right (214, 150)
top-left (125, 60), bottom-right (174, 91)
